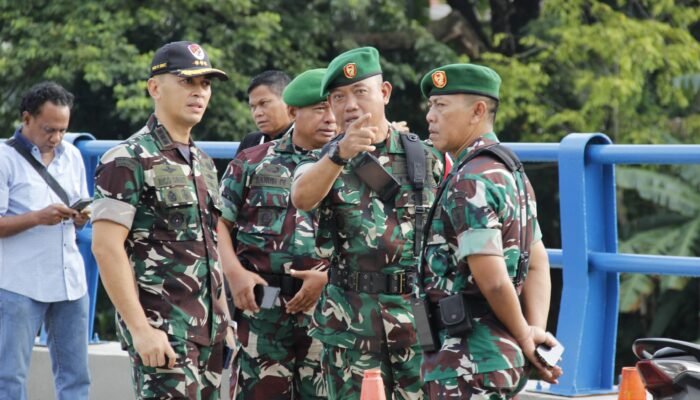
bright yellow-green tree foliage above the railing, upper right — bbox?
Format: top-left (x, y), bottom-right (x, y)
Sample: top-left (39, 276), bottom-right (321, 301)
top-left (484, 0), bottom-right (700, 143)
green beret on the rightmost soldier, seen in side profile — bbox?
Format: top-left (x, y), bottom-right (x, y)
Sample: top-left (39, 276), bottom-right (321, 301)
top-left (420, 64), bottom-right (501, 100)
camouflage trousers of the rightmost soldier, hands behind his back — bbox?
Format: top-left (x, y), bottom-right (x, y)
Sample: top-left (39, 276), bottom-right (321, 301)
top-left (424, 368), bottom-right (527, 400)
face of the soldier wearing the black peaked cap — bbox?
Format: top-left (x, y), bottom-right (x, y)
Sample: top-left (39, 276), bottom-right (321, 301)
top-left (151, 74), bottom-right (211, 128)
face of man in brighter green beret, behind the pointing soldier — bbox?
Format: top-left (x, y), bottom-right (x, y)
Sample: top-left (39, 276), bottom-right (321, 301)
top-left (294, 101), bottom-right (337, 150)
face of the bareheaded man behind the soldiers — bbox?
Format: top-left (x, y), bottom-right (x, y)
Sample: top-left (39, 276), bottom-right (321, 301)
top-left (248, 85), bottom-right (292, 135)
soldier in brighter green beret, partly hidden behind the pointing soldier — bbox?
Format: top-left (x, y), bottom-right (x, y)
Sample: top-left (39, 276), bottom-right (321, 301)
top-left (219, 69), bottom-right (336, 400)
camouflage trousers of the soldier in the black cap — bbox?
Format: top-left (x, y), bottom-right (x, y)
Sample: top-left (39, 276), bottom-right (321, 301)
top-left (126, 336), bottom-right (224, 400)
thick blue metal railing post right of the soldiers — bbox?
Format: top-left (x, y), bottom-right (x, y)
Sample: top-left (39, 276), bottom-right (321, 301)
top-left (549, 133), bottom-right (619, 396)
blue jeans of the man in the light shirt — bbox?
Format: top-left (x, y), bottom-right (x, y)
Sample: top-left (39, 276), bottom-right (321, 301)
top-left (0, 289), bottom-right (90, 400)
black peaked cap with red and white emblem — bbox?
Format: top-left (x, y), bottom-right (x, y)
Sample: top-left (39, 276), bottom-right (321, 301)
top-left (149, 41), bottom-right (228, 80)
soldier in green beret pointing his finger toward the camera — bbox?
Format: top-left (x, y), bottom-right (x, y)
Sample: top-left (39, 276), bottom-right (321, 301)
top-left (292, 47), bottom-right (443, 399)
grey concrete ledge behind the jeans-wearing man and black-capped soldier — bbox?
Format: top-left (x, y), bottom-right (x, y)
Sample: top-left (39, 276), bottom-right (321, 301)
top-left (28, 342), bottom-right (230, 400)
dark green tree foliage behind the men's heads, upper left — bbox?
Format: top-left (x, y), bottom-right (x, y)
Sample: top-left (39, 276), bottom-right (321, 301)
top-left (0, 0), bottom-right (452, 140)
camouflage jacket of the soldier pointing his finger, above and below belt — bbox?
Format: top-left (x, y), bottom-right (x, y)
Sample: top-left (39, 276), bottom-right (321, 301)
top-left (310, 131), bottom-right (443, 353)
